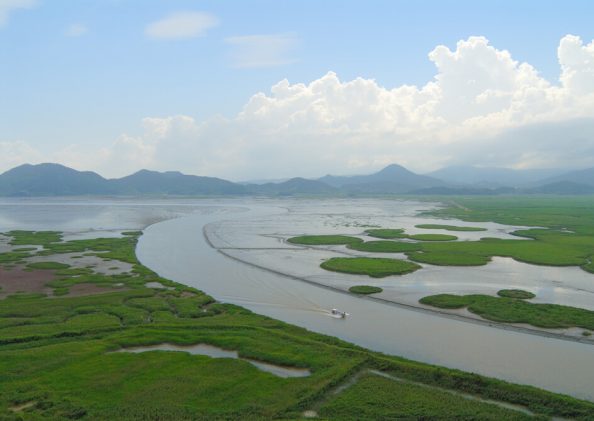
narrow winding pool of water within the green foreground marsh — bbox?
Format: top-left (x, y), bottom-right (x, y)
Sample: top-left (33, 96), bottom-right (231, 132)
top-left (116, 343), bottom-right (311, 378)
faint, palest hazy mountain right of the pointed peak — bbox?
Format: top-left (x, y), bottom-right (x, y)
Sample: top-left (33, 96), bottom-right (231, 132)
top-left (427, 166), bottom-right (563, 187)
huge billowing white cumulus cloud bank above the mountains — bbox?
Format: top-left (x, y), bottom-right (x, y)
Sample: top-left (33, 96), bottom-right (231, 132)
top-left (6, 35), bottom-right (594, 179)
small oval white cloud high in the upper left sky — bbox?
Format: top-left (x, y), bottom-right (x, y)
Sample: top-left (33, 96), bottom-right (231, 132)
top-left (145, 12), bottom-right (219, 39)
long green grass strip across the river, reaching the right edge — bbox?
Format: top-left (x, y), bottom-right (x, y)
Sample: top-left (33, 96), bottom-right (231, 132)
top-left (419, 291), bottom-right (594, 330)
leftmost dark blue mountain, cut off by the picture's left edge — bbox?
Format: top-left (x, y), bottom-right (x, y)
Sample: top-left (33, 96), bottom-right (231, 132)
top-left (0, 164), bottom-right (113, 196)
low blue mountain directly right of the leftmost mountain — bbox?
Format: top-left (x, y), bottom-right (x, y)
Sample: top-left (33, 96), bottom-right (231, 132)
top-left (109, 170), bottom-right (246, 195)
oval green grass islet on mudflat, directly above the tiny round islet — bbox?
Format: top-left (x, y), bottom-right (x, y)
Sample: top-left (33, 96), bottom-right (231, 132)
top-left (320, 257), bottom-right (421, 278)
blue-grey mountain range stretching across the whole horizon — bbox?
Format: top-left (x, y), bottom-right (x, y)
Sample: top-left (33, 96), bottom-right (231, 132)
top-left (0, 163), bottom-right (594, 196)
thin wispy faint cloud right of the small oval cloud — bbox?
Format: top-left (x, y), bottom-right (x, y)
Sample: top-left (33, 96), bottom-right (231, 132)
top-left (225, 34), bottom-right (298, 68)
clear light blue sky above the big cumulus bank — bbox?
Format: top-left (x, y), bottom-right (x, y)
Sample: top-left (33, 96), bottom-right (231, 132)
top-left (0, 0), bottom-right (594, 177)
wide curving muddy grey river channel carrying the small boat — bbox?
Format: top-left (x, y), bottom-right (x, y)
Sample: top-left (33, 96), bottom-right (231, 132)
top-left (137, 203), bottom-right (594, 400)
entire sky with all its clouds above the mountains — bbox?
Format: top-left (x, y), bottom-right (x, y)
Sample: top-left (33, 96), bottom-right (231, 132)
top-left (0, 0), bottom-right (594, 181)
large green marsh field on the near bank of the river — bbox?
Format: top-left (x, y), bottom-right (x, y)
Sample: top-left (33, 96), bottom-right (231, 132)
top-left (0, 234), bottom-right (594, 420)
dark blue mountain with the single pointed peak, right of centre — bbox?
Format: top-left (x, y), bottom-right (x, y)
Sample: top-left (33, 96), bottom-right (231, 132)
top-left (318, 164), bottom-right (446, 194)
